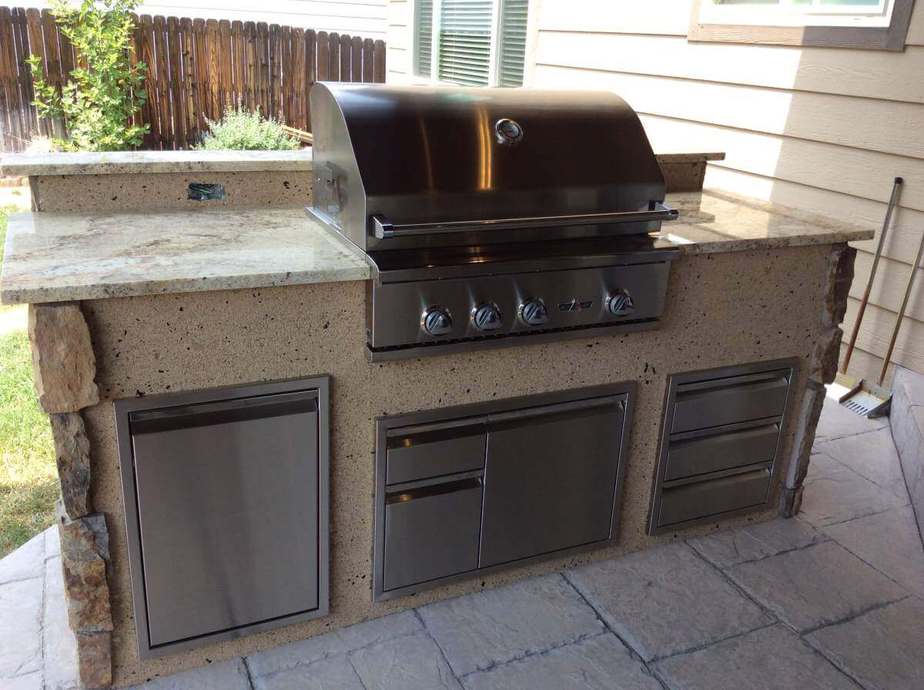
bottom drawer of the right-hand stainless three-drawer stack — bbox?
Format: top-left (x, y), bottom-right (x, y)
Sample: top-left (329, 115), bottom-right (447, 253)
top-left (658, 469), bottom-right (770, 527)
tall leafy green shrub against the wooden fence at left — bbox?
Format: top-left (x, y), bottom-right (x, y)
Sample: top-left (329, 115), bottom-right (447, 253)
top-left (29, 0), bottom-right (148, 151)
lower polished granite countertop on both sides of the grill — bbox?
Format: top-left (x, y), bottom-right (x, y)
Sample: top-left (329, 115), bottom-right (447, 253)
top-left (0, 189), bottom-right (875, 304)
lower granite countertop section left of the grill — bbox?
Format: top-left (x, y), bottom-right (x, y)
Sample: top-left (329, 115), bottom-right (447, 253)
top-left (0, 207), bottom-right (371, 304)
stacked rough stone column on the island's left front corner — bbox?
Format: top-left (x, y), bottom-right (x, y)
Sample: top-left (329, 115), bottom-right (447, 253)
top-left (29, 303), bottom-right (113, 688)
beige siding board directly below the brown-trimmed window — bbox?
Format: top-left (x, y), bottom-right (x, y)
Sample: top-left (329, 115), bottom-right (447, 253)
top-left (536, 31), bottom-right (924, 103)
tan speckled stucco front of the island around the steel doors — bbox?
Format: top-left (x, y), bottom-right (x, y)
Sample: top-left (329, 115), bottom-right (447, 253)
top-left (39, 245), bottom-right (843, 686)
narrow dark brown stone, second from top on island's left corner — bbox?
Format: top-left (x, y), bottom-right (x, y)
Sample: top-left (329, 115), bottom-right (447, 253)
top-left (48, 412), bottom-right (93, 520)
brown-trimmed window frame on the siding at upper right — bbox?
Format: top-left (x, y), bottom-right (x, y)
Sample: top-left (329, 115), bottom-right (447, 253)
top-left (687, 0), bottom-right (914, 52)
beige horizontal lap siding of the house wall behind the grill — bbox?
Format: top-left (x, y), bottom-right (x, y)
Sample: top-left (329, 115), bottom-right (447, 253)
top-left (386, 0), bottom-right (924, 376)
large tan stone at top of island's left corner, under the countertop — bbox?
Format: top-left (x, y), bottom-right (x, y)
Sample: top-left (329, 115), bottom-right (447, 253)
top-left (29, 302), bottom-right (99, 414)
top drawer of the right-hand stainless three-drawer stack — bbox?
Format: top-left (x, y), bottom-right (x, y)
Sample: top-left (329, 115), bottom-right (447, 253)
top-left (671, 371), bottom-right (789, 434)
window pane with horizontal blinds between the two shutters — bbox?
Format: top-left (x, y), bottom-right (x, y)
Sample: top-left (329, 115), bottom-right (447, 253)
top-left (438, 0), bottom-right (494, 86)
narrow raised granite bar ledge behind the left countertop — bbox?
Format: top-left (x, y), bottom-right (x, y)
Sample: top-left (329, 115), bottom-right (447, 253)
top-left (0, 149), bottom-right (311, 177)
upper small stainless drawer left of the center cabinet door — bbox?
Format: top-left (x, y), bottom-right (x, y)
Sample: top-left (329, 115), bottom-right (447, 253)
top-left (385, 424), bottom-right (487, 484)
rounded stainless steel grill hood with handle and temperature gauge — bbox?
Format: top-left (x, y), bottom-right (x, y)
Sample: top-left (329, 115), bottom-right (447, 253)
top-left (310, 83), bottom-right (672, 251)
